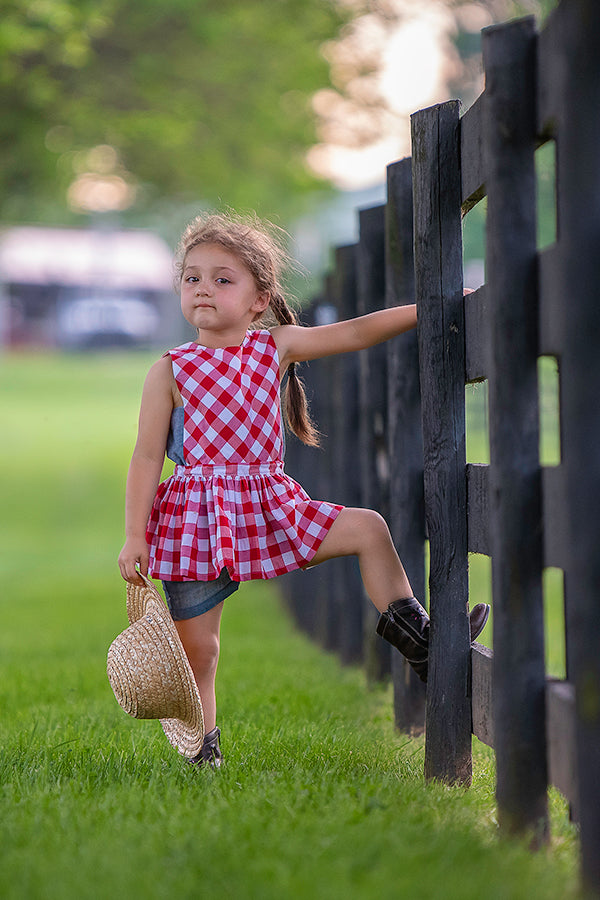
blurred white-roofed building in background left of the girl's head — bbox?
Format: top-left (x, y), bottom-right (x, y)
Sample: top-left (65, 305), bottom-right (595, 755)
top-left (0, 226), bottom-right (181, 348)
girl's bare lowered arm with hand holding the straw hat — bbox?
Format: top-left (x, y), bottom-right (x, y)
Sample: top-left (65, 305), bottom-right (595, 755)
top-left (119, 357), bottom-right (176, 583)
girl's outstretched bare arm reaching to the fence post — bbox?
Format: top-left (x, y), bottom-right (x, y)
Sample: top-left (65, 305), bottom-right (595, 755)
top-left (272, 304), bottom-right (417, 371)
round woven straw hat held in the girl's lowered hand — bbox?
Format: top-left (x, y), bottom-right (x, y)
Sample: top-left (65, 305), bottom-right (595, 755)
top-left (106, 575), bottom-right (204, 759)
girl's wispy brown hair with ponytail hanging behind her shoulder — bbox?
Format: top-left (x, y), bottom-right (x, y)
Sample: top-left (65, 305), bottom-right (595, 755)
top-left (175, 213), bottom-right (319, 447)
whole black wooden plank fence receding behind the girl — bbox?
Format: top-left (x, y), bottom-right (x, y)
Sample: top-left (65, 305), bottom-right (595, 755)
top-left (278, 0), bottom-right (600, 891)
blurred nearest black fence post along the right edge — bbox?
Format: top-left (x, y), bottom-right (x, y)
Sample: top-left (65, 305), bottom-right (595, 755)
top-left (558, 0), bottom-right (600, 894)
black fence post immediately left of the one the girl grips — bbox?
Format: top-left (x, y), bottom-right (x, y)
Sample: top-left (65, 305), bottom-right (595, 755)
top-left (385, 159), bottom-right (425, 731)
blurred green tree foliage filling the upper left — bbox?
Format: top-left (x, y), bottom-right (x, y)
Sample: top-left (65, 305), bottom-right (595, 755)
top-left (0, 0), bottom-right (343, 229)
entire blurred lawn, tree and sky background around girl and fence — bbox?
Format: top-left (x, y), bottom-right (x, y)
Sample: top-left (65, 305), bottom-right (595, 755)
top-left (0, 0), bottom-right (578, 900)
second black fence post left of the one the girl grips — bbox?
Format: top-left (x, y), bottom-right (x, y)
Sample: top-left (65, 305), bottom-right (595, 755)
top-left (356, 206), bottom-right (391, 681)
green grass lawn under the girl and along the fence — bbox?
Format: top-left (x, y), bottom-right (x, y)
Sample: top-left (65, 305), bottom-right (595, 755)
top-left (0, 355), bottom-right (577, 900)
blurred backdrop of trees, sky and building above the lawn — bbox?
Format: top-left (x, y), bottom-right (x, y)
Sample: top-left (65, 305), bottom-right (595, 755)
top-left (0, 0), bottom-right (556, 349)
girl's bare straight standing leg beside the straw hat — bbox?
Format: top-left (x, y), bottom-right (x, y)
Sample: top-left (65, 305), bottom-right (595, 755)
top-left (175, 603), bottom-right (223, 734)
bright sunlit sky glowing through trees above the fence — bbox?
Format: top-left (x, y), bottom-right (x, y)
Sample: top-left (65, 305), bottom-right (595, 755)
top-left (308, 0), bottom-right (491, 190)
